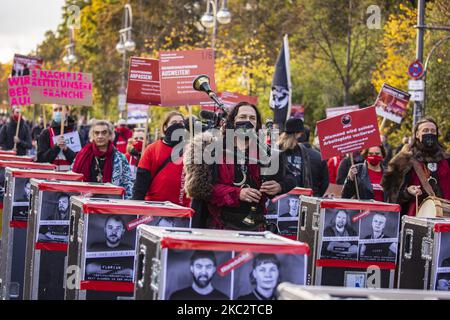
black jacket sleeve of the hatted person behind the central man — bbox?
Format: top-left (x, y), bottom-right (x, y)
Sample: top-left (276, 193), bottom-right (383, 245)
top-left (303, 143), bottom-right (330, 198)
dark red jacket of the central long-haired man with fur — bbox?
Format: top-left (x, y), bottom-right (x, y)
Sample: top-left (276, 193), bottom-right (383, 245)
top-left (208, 163), bottom-right (266, 229)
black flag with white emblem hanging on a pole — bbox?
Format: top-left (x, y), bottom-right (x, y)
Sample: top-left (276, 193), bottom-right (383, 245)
top-left (269, 35), bottom-right (292, 129)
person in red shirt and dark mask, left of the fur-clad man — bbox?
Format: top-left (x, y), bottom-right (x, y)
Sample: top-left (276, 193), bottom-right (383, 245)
top-left (133, 111), bottom-right (190, 207)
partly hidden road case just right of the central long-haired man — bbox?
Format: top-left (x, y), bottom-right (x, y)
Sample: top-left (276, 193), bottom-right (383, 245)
top-left (266, 188), bottom-right (313, 240)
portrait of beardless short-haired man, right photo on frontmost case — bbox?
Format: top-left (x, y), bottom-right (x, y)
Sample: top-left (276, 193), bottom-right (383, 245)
top-left (233, 252), bottom-right (306, 300)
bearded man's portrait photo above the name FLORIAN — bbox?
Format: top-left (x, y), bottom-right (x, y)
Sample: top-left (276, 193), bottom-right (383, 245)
top-left (87, 214), bottom-right (137, 252)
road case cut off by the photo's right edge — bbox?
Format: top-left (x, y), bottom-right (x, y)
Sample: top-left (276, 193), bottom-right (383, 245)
top-left (398, 216), bottom-right (450, 291)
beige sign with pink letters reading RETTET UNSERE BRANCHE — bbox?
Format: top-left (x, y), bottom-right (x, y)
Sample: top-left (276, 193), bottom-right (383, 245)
top-left (30, 70), bottom-right (92, 107)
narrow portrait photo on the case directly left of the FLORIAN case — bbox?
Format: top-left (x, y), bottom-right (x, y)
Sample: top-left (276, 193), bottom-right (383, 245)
top-left (38, 192), bottom-right (70, 243)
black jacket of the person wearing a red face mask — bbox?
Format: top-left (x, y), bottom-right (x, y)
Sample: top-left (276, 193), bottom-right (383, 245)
top-left (342, 162), bottom-right (386, 201)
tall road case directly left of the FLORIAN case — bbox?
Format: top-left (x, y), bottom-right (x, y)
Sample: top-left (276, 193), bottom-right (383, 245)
top-left (24, 179), bottom-right (125, 300)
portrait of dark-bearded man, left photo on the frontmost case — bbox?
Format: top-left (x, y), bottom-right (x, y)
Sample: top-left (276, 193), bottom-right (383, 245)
top-left (163, 249), bottom-right (231, 300)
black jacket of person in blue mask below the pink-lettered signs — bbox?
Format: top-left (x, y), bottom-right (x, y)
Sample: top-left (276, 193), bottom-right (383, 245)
top-left (37, 117), bottom-right (76, 163)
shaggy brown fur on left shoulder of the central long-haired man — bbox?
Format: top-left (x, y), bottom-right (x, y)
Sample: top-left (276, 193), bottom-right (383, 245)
top-left (183, 131), bottom-right (217, 200)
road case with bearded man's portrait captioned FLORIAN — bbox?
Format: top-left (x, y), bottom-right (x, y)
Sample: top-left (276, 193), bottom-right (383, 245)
top-left (65, 197), bottom-right (194, 300)
